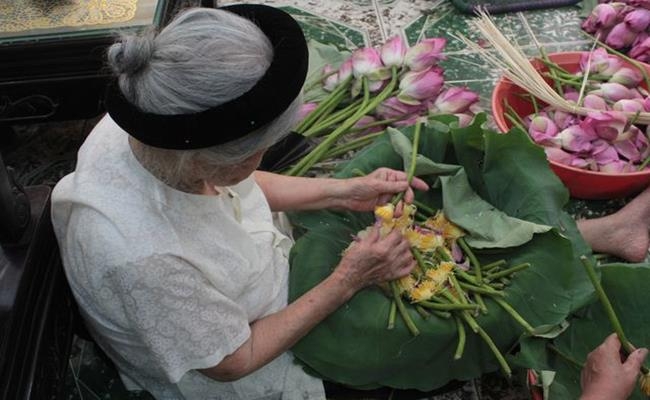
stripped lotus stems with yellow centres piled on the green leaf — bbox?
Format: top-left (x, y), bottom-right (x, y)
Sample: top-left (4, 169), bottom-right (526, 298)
top-left (350, 202), bottom-right (534, 375)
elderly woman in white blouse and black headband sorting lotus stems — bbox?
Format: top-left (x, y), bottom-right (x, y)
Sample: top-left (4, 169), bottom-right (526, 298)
top-left (52, 5), bottom-right (427, 399)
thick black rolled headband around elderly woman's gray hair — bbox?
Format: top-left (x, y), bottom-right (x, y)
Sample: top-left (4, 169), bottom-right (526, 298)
top-left (106, 4), bottom-right (308, 150)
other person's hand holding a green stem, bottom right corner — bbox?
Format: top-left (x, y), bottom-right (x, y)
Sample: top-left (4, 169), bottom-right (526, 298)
top-left (580, 333), bottom-right (648, 400)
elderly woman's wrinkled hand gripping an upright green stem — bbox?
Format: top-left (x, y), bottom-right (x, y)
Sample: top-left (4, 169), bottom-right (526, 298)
top-left (340, 168), bottom-right (429, 211)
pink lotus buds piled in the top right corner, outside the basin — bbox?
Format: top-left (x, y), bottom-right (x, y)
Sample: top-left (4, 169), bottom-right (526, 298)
top-left (582, 0), bottom-right (650, 62)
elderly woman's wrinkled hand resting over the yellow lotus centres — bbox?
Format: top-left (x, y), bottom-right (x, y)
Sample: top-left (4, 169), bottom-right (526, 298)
top-left (335, 224), bottom-right (415, 291)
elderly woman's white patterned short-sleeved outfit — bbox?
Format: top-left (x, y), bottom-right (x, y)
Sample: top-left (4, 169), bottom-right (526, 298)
top-left (52, 115), bottom-right (325, 400)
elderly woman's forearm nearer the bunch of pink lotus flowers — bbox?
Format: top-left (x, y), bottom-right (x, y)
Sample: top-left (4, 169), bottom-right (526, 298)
top-left (254, 171), bottom-right (345, 211)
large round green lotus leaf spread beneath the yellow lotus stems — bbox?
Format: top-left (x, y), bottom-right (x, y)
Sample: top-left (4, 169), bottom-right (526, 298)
top-left (289, 115), bottom-right (593, 391)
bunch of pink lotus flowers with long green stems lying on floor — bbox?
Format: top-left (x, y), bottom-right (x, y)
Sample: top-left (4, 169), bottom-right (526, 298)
top-left (286, 36), bottom-right (480, 175)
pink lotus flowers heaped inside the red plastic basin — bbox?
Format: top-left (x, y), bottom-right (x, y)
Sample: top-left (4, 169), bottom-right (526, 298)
top-left (509, 48), bottom-right (650, 173)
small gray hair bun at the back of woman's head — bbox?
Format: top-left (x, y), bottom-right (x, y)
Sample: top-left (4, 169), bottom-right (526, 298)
top-left (108, 32), bottom-right (154, 75)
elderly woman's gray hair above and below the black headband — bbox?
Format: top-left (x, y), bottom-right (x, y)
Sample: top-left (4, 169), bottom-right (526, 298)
top-left (108, 8), bottom-right (301, 191)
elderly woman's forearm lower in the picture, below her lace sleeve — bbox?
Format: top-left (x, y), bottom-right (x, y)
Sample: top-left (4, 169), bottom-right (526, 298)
top-left (201, 271), bottom-right (355, 381)
